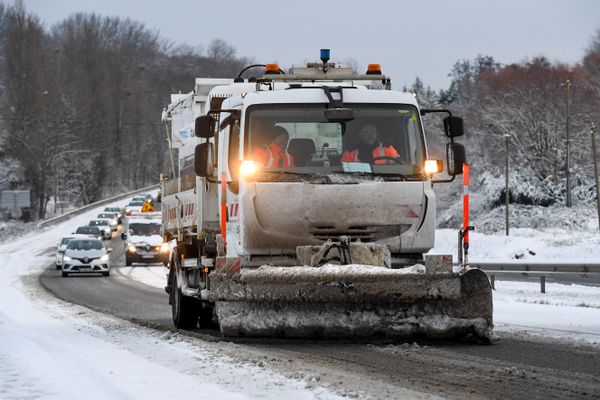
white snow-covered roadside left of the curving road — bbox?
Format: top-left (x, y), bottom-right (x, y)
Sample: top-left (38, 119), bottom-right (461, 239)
top-left (0, 202), bottom-right (338, 399)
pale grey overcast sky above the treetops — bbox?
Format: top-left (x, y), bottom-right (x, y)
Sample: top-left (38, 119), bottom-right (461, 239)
top-left (12, 0), bottom-right (600, 89)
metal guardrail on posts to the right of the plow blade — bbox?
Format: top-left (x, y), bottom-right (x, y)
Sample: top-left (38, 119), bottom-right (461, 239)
top-left (469, 262), bottom-right (600, 293)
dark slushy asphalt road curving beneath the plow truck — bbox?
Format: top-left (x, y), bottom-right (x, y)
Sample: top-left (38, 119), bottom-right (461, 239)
top-left (41, 228), bottom-right (600, 399)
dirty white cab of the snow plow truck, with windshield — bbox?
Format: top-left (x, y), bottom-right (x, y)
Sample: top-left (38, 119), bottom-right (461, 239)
top-left (183, 63), bottom-right (460, 267)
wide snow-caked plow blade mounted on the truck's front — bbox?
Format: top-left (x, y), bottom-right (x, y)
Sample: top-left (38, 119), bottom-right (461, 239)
top-left (210, 265), bottom-right (492, 341)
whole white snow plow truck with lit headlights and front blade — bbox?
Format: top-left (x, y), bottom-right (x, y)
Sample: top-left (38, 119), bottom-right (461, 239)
top-left (161, 50), bottom-right (492, 341)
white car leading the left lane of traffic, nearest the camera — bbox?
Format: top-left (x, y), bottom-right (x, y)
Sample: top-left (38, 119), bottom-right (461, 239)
top-left (61, 239), bottom-right (112, 277)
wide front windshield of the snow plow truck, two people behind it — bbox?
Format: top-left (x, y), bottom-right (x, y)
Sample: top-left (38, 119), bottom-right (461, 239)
top-left (245, 104), bottom-right (425, 175)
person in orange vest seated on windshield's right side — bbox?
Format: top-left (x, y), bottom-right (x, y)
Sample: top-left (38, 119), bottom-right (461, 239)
top-left (341, 124), bottom-right (399, 164)
